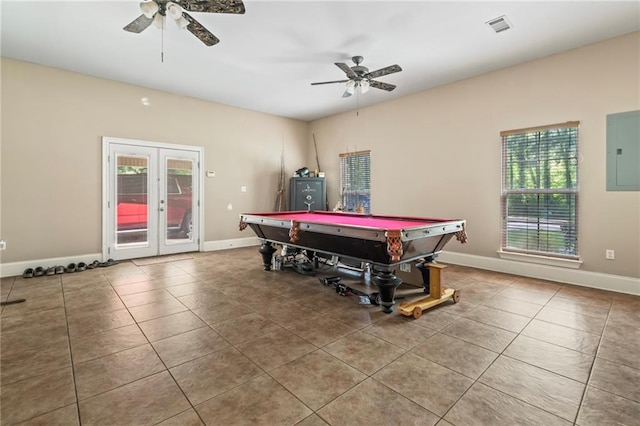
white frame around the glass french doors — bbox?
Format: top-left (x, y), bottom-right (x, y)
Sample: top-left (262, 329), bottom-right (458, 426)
top-left (102, 136), bottom-right (204, 260)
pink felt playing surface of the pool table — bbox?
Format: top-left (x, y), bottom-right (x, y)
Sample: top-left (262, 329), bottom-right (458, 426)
top-left (258, 212), bottom-right (441, 230)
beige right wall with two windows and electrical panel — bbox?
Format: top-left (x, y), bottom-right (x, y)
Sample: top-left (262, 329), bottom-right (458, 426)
top-left (307, 33), bottom-right (640, 277)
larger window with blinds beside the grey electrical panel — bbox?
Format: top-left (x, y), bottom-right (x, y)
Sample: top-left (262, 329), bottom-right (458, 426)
top-left (500, 121), bottom-right (580, 259)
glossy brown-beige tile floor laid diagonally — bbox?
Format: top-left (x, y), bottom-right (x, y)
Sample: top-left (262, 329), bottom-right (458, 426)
top-left (0, 247), bottom-right (640, 426)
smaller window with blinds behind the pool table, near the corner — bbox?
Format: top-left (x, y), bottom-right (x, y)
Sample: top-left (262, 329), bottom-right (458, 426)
top-left (340, 151), bottom-right (371, 213)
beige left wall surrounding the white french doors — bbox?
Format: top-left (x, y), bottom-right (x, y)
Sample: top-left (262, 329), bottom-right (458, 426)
top-left (0, 58), bottom-right (308, 263)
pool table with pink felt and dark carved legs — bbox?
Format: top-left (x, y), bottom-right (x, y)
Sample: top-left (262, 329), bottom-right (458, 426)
top-left (240, 211), bottom-right (467, 313)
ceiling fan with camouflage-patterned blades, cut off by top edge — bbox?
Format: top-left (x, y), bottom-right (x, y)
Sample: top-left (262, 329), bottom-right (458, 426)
top-left (123, 0), bottom-right (245, 46)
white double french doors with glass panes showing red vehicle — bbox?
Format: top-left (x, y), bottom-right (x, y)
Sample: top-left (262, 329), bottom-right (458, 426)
top-left (103, 138), bottom-right (202, 260)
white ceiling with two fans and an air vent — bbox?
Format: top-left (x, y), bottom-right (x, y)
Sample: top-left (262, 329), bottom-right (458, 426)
top-left (0, 0), bottom-right (640, 121)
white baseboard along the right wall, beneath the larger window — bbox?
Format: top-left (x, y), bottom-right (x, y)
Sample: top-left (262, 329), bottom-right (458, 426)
top-left (438, 251), bottom-right (640, 295)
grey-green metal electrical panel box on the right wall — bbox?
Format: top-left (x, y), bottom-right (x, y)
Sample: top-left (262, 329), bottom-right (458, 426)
top-left (607, 111), bottom-right (640, 191)
